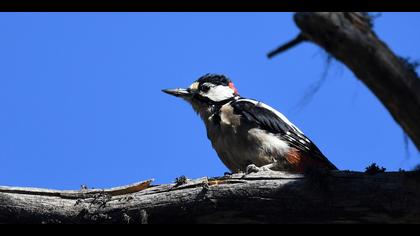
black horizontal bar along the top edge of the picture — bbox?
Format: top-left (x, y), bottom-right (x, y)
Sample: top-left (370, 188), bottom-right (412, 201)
top-left (0, 0), bottom-right (420, 12)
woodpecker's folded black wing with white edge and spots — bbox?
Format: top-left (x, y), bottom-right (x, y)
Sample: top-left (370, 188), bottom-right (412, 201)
top-left (231, 99), bottom-right (337, 169)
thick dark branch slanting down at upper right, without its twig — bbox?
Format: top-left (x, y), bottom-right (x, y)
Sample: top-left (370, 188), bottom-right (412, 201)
top-left (270, 12), bottom-right (420, 150)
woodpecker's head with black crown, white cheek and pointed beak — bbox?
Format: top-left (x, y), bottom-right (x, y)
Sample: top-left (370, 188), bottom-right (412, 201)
top-left (162, 74), bottom-right (239, 113)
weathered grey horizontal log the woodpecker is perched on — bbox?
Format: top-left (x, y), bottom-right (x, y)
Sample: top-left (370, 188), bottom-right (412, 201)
top-left (0, 172), bottom-right (420, 224)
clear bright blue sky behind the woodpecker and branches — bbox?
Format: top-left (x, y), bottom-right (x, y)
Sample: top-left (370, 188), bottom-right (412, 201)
top-left (0, 13), bottom-right (420, 189)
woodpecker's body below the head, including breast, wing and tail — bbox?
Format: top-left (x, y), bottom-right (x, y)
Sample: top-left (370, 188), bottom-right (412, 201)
top-left (206, 98), bottom-right (337, 172)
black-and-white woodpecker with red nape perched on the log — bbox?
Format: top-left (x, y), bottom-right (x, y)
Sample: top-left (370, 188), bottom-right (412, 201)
top-left (162, 74), bottom-right (337, 173)
